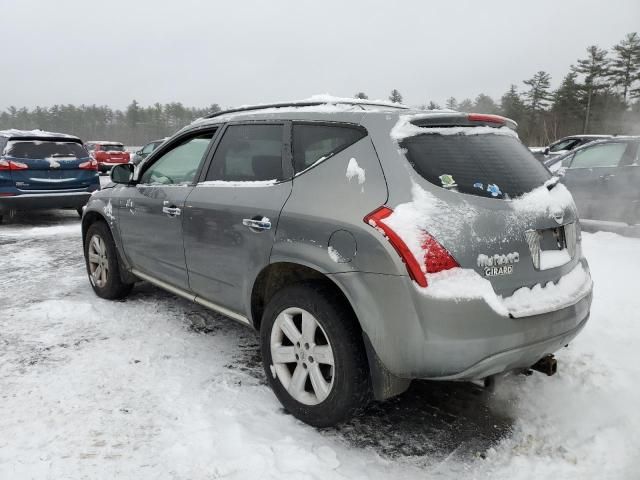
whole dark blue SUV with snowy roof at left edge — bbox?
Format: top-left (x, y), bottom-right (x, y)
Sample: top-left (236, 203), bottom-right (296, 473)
top-left (0, 130), bottom-right (100, 222)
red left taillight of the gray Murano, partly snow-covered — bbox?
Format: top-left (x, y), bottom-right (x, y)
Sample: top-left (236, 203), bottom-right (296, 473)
top-left (364, 207), bottom-right (460, 287)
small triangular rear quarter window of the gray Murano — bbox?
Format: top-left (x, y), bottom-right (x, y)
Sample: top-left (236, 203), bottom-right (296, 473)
top-left (293, 123), bottom-right (367, 173)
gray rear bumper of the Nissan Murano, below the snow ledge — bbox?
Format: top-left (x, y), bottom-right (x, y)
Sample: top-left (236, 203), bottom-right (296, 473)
top-left (333, 263), bottom-right (592, 380)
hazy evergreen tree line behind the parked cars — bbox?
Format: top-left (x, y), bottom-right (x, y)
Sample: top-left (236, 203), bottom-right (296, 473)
top-left (0, 32), bottom-right (640, 145)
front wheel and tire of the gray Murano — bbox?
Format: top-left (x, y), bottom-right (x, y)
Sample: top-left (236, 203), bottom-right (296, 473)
top-left (84, 222), bottom-right (133, 300)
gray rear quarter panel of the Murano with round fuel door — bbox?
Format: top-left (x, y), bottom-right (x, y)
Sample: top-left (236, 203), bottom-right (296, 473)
top-left (271, 137), bottom-right (400, 274)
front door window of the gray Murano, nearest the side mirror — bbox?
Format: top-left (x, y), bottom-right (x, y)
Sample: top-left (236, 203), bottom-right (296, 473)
top-left (140, 132), bottom-right (215, 185)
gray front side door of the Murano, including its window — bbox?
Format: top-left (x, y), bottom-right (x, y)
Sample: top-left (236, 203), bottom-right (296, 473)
top-left (118, 131), bottom-right (214, 289)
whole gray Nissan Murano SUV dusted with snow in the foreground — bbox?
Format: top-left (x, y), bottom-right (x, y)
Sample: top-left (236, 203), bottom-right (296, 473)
top-left (82, 101), bottom-right (592, 426)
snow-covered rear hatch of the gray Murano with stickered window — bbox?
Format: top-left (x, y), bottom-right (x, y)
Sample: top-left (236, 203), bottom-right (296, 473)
top-left (387, 115), bottom-right (580, 304)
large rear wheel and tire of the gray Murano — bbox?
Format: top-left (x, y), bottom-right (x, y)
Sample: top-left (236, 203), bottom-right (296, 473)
top-left (260, 282), bottom-right (371, 427)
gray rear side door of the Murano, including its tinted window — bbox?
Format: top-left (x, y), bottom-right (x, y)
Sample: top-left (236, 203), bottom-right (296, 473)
top-left (184, 122), bottom-right (291, 315)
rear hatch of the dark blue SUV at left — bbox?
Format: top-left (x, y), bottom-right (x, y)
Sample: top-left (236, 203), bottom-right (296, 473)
top-left (2, 137), bottom-right (97, 192)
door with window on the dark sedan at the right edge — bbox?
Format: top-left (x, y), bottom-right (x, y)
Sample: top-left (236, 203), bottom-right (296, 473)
top-left (563, 141), bottom-right (631, 220)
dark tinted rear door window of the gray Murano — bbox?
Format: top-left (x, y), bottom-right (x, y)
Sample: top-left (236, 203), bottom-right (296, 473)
top-left (206, 125), bottom-right (284, 182)
